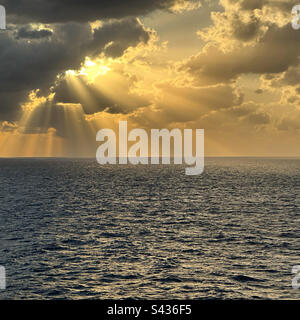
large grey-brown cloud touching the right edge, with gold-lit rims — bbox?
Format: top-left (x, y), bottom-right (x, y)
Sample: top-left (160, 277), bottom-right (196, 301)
top-left (179, 25), bottom-right (300, 85)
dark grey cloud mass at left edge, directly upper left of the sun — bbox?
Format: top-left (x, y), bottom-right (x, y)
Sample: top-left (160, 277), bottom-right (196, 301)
top-left (0, 18), bottom-right (149, 120)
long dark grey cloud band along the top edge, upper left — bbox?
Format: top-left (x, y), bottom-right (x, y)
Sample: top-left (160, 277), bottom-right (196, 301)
top-left (1, 0), bottom-right (182, 23)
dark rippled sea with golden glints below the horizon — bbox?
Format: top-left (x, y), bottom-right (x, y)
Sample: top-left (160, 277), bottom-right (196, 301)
top-left (0, 158), bottom-right (300, 299)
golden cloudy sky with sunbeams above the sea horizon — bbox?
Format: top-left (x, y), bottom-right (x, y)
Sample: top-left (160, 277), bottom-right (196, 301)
top-left (0, 0), bottom-right (300, 157)
